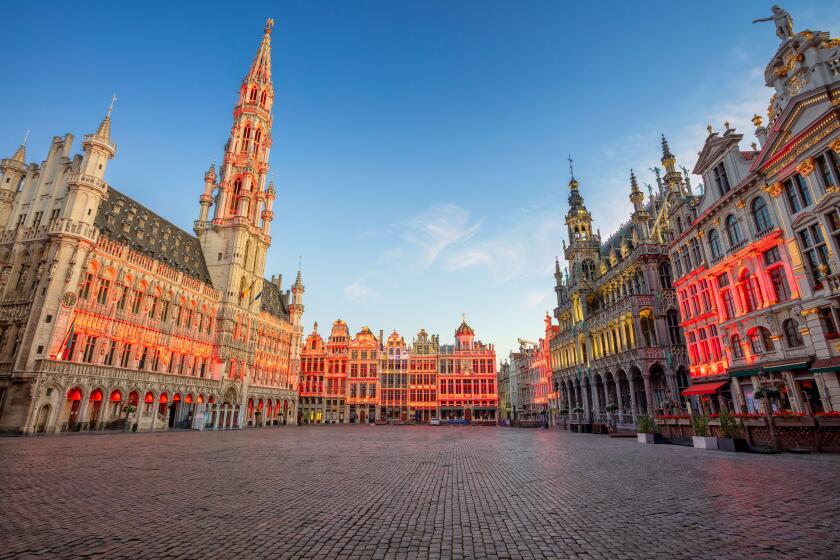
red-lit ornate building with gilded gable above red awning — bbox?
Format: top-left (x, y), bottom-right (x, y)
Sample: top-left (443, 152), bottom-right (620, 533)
top-left (663, 21), bottom-right (840, 412)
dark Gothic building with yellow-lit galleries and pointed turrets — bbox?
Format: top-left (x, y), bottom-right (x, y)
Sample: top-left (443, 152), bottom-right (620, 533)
top-left (547, 166), bottom-right (690, 429)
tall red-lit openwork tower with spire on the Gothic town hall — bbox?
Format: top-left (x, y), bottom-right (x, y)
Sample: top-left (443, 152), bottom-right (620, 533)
top-left (194, 19), bottom-right (276, 313)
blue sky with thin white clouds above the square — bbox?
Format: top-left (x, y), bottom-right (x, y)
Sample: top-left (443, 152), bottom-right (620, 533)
top-left (0, 0), bottom-right (840, 355)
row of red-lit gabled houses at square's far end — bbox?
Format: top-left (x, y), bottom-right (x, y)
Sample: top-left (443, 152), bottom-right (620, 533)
top-left (299, 321), bottom-right (498, 424)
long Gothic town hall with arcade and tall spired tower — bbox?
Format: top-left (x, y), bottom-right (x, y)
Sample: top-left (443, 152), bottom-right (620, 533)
top-left (0, 20), bottom-right (304, 433)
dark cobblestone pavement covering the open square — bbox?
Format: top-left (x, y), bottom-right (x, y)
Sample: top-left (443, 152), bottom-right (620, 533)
top-left (0, 426), bottom-right (840, 560)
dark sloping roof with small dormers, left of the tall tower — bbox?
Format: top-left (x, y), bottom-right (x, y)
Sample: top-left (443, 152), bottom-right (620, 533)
top-left (94, 187), bottom-right (212, 285)
